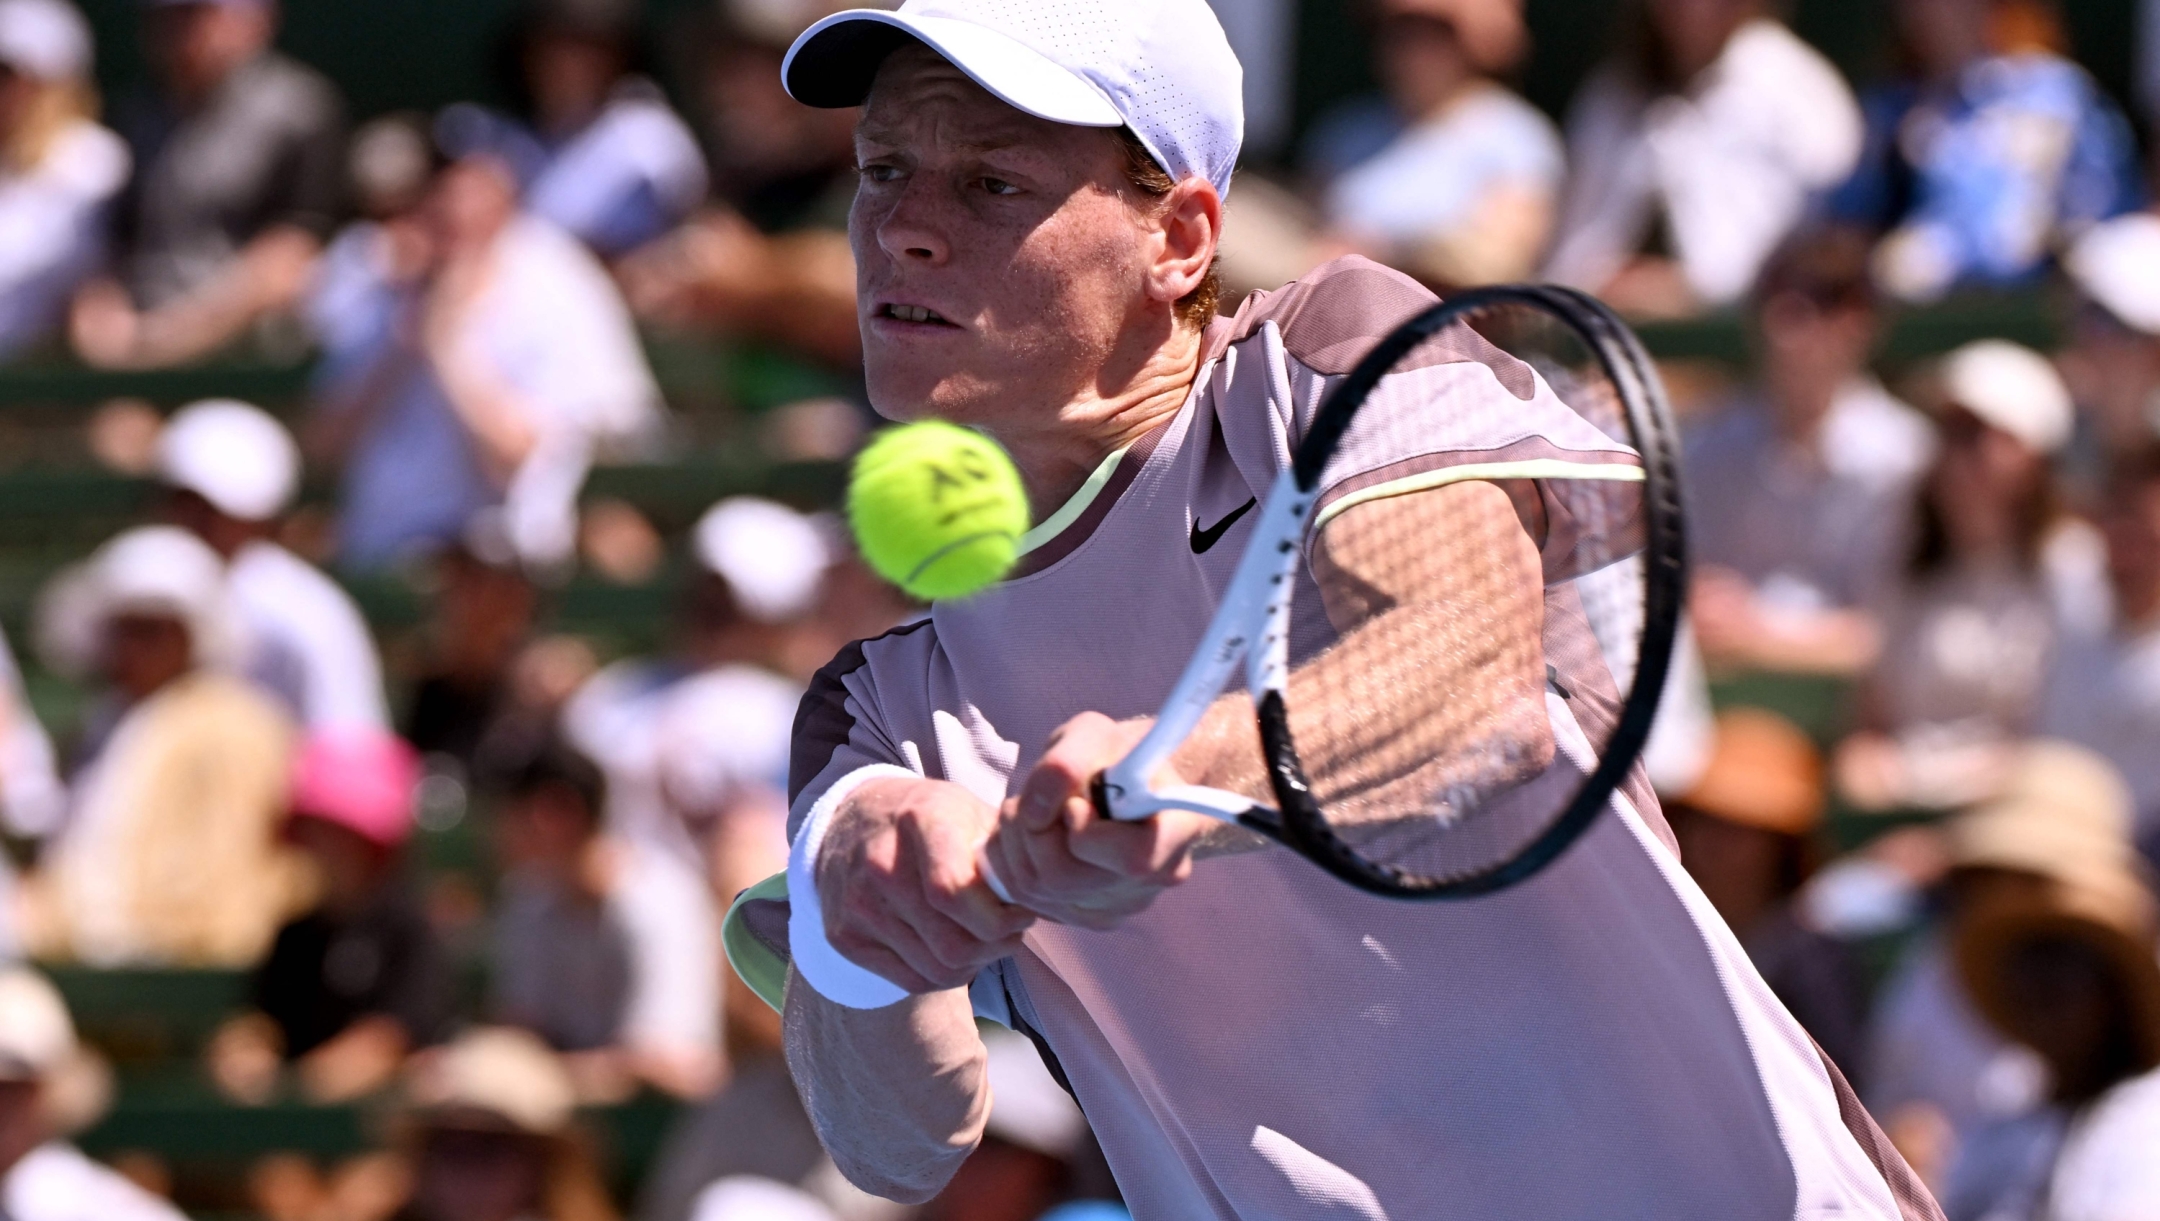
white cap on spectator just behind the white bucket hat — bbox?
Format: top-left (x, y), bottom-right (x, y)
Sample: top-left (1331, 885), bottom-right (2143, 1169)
top-left (157, 395), bottom-right (300, 521)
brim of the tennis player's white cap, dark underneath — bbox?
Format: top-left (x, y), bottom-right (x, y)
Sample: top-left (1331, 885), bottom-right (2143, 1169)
top-left (780, 9), bottom-right (1125, 128)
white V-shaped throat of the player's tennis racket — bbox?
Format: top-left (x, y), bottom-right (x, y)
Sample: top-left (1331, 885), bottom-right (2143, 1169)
top-left (1104, 469), bottom-right (1315, 823)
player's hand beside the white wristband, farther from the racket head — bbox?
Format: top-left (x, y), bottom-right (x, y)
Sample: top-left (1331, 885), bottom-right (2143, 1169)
top-left (816, 778), bottom-right (1035, 992)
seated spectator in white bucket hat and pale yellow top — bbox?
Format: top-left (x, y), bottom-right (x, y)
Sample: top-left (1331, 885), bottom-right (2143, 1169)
top-left (26, 525), bottom-right (298, 968)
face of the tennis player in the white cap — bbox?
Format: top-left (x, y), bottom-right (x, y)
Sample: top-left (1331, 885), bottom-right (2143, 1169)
top-left (849, 48), bottom-right (1149, 432)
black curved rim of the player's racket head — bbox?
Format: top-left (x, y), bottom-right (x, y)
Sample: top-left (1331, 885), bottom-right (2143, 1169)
top-left (1240, 285), bottom-right (1687, 901)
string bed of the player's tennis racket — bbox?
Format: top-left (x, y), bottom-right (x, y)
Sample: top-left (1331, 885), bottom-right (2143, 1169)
top-left (1285, 307), bottom-right (1644, 877)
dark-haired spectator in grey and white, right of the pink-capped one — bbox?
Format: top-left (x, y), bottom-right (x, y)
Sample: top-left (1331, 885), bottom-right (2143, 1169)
top-left (492, 748), bottom-right (721, 1098)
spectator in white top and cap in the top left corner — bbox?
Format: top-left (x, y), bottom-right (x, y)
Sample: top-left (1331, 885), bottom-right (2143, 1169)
top-left (0, 0), bottom-right (130, 359)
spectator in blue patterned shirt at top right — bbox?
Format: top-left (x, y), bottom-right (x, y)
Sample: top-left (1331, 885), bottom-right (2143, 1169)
top-left (1830, 0), bottom-right (2143, 300)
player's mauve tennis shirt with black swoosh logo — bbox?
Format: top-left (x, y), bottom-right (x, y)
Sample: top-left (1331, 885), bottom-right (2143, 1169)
top-left (791, 259), bottom-right (1940, 1221)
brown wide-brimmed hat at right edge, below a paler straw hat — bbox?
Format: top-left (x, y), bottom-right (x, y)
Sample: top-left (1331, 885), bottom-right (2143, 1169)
top-left (1950, 884), bottom-right (2160, 1072)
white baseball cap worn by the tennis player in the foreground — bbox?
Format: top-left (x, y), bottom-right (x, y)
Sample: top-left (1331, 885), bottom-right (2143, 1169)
top-left (780, 0), bottom-right (1244, 197)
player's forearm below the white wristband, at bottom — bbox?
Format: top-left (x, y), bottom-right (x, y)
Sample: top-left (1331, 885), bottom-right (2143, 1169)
top-left (782, 968), bottom-right (989, 1204)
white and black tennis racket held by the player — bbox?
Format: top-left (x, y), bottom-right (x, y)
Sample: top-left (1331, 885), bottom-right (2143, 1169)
top-left (1093, 285), bottom-right (1685, 899)
